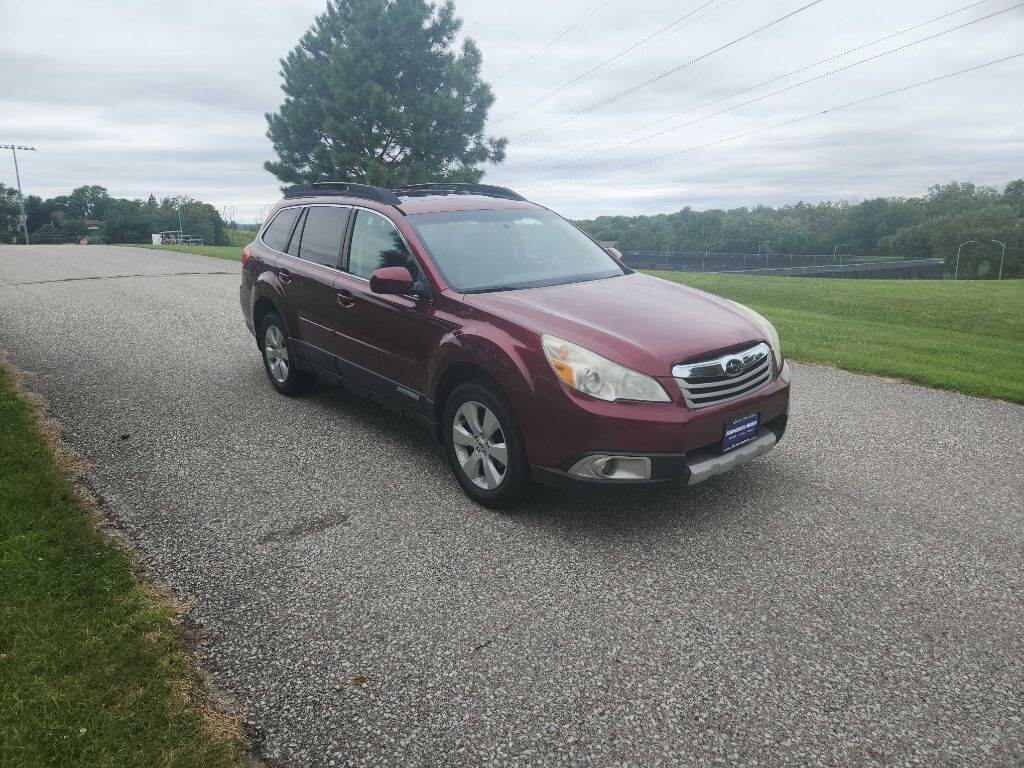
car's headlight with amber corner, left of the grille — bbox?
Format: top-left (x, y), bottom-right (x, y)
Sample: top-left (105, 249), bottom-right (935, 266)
top-left (541, 334), bottom-right (671, 402)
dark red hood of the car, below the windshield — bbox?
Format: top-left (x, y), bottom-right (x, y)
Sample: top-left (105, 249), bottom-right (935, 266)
top-left (464, 272), bottom-right (764, 376)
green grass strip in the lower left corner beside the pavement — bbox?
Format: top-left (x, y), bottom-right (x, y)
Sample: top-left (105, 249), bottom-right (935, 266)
top-left (0, 369), bottom-right (237, 768)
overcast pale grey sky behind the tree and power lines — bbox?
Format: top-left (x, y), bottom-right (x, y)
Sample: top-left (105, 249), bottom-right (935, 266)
top-left (0, 0), bottom-right (1024, 220)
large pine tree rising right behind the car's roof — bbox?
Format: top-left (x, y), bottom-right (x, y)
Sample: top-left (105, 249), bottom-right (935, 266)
top-left (263, 0), bottom-right (507, 186)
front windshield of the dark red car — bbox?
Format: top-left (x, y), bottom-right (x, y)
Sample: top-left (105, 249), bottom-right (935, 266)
top-left (409, 208), bottom-right (625, 293)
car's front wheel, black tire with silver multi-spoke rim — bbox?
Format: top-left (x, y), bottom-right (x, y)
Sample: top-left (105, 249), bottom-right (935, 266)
top-left (441, 379), bottom-right (530, 509)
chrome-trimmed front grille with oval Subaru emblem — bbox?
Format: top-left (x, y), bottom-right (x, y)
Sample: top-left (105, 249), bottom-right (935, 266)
top-left (672, 342), bottom-right (772, 408)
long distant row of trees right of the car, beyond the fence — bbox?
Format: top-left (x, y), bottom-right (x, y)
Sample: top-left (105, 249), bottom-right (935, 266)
top-left (577, 178), bottom-right (1024, 278)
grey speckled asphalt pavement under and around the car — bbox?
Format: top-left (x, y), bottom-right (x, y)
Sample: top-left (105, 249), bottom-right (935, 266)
top-left (0, 246), bottom-right (1024, 766)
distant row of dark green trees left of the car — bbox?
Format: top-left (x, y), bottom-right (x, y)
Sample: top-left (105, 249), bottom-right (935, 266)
top-left (0, 184), bottom-right (228, 245)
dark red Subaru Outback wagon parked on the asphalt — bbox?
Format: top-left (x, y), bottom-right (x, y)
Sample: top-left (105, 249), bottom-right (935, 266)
top-left (241, 183), bottom-right (790, 507)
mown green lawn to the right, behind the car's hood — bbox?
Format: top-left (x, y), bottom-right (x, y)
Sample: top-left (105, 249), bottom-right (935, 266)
top-left (650, 271), bottom-right (1024, 402)
